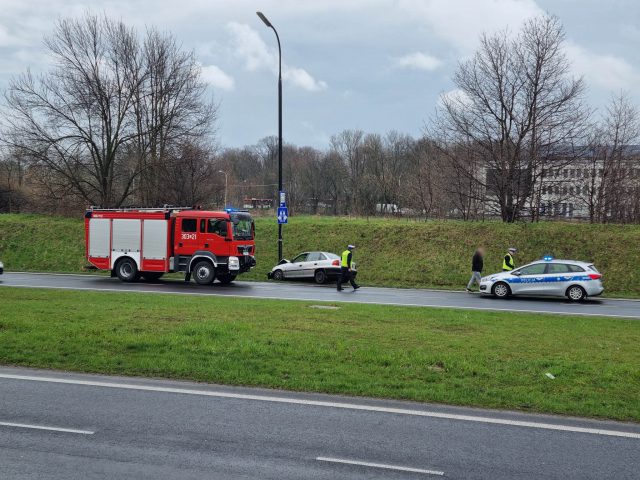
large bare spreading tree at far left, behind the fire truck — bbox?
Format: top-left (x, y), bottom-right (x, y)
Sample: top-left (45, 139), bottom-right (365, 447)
top-left (4, 16), bottom-right (143, 205)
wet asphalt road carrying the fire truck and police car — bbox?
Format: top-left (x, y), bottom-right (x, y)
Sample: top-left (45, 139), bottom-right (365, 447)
top-left (0, 272), bottom-right (640, 318)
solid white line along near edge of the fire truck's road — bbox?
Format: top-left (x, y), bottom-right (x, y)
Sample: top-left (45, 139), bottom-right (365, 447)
top-left (0, 277), bottom-right (640, 319)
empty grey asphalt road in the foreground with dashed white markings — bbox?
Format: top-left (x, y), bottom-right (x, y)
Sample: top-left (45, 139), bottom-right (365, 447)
top-left (0, 368), bottom-right (640, 480)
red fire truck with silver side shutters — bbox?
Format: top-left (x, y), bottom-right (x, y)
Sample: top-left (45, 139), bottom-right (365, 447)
top-left (85, 207), bottom-right (256, 285)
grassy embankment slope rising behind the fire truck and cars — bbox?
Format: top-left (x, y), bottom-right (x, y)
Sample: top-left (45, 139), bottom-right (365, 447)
top-left (0, 215), bottom-right (640, 297)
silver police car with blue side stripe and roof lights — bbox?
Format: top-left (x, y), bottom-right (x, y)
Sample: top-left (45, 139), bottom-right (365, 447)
top-left (480, 256), bottom-right (604, 302)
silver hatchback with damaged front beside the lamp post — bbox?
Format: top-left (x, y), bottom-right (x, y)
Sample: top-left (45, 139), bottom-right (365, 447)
top-left (267, 252), bottom-right (357, 284)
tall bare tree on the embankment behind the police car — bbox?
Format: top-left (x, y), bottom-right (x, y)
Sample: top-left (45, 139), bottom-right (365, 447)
top-left (435, 16), bottom-right (588, 222)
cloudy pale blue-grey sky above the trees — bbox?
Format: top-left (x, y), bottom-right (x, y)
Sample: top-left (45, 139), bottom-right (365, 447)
top-left (0, 0), bottom-right (640, 147)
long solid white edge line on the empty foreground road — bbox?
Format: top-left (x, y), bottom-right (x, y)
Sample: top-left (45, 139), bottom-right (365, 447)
top-left (0, 373), bottom-right (640, 440)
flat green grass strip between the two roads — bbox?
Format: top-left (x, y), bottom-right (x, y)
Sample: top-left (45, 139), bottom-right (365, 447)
top-left (0, 287), bottom-right (640, 421)
